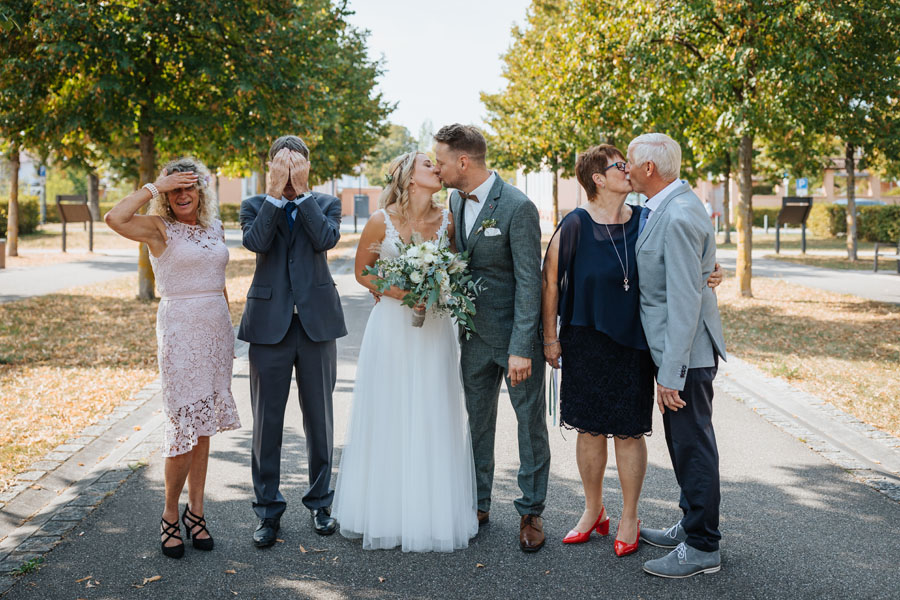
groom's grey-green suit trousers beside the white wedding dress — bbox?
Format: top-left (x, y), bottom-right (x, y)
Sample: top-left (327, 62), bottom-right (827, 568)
top-left (460, 334), bottom-right (550, 516)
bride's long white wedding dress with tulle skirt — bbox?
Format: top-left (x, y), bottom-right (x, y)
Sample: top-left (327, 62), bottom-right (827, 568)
top-left (332, 211), bottom-right (478, 552)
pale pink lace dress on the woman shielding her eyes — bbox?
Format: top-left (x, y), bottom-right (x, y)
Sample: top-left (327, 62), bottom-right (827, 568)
top-left (150, 219), bottom-right (241, 457)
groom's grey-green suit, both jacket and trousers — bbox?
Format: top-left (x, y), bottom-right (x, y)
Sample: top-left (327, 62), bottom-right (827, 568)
top-left (450, 175), bottom-right (550, 515)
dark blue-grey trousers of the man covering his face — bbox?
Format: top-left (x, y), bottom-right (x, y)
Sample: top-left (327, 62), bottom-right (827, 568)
top-left (249, 315), bottom-right (337, 519)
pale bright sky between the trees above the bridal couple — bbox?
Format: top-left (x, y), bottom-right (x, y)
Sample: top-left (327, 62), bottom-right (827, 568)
top-left (342, 0), bottom-right (530, 135)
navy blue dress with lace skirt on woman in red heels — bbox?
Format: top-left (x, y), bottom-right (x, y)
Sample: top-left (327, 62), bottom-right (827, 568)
top-left (557, 207), bottom-right (653, 438)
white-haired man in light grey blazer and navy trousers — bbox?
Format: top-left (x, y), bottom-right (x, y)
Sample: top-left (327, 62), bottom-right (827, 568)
top-left (626, 133), bottom-right (725, 578)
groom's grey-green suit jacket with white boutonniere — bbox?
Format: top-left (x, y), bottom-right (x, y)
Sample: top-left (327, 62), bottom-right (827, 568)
top-left (450, 175), bottom-right (542, 360)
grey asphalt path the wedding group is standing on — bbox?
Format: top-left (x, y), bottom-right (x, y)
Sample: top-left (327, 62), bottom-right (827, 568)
top-left (0, 275), bottom-right (900, 600)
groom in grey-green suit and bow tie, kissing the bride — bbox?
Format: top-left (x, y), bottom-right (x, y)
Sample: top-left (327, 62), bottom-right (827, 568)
top-left (434, 124), bottom-right (550, 552)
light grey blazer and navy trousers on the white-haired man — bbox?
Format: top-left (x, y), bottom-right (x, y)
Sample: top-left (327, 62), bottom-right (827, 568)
top-left (635, 183), bottom-right (725, 552)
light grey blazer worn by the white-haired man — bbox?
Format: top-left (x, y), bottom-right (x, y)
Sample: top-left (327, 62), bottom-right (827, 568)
top-left (636, 183), bottom-right (726, 391)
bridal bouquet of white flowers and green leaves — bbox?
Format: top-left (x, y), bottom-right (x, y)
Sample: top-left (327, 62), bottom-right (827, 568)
top-left (363, 234), bottom-right (483, 339)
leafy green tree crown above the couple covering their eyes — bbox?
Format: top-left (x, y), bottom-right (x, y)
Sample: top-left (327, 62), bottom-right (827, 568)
top-left (34, 0), bottom-right (390, 298)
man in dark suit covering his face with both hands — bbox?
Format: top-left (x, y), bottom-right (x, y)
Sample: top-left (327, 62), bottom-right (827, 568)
top-left (238, 136), bottom-right (347, 548)
